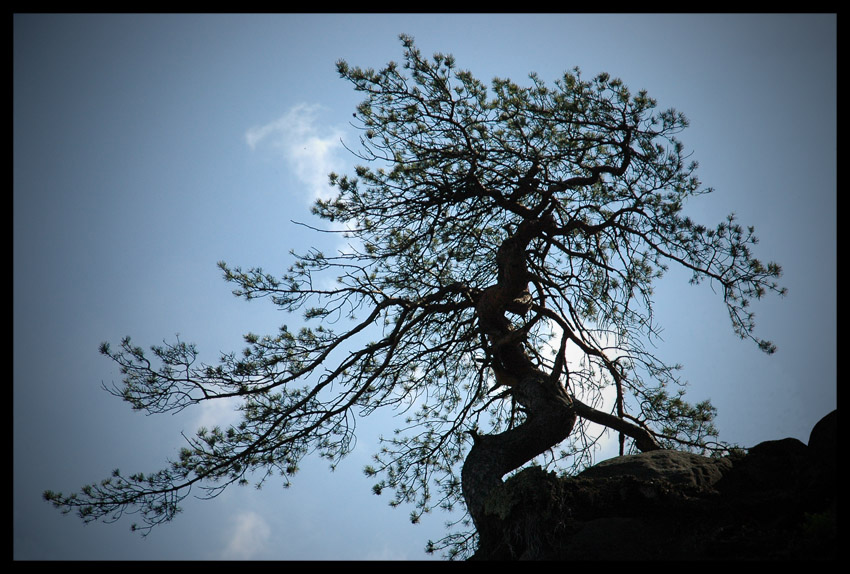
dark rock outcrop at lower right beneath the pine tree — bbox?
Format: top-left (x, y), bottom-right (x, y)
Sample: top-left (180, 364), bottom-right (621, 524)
top-left (474, 411), bottom-right (837, 560)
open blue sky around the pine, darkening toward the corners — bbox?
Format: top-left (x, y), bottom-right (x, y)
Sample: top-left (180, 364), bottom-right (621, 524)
top-left (13, 14), bottom-right (837, 559)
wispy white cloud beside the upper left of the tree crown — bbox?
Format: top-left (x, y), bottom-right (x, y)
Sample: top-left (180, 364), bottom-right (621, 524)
top-left (245, 104), bottom-right (344, 202)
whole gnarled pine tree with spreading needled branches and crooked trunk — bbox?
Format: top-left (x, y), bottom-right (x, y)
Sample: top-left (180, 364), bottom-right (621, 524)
top-left (45, 36), bottom-right (783, 556)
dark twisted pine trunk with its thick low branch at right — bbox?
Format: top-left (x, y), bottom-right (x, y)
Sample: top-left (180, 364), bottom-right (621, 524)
top-left (461, 215), bottom-right (660, 545)
